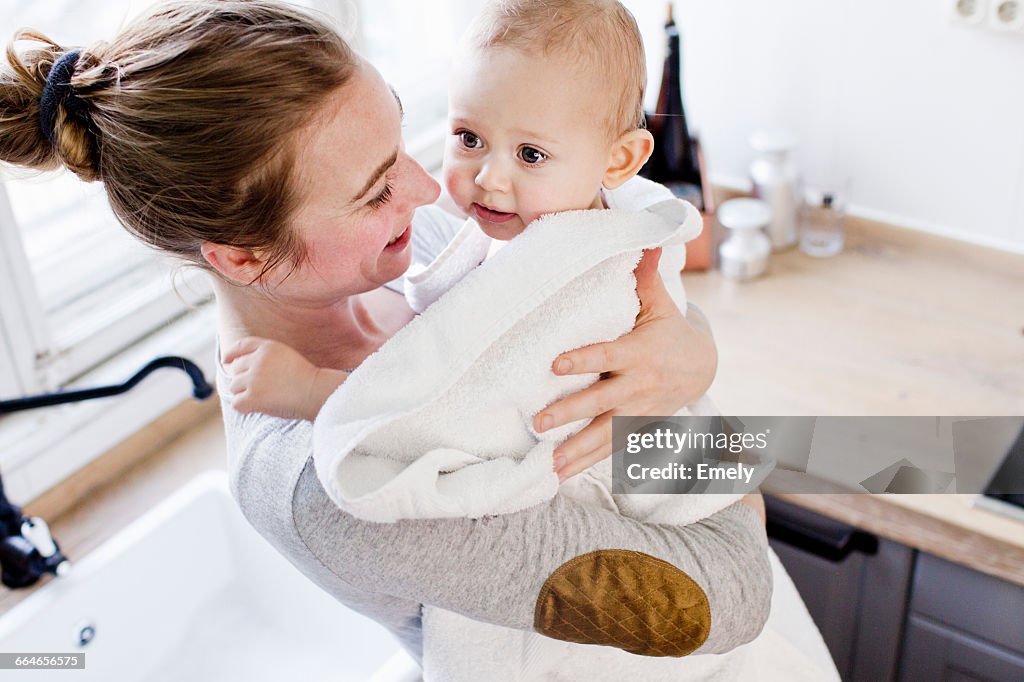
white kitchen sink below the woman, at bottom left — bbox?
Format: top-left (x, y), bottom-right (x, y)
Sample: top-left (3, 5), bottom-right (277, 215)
top-left (0, 472), bottom-right (420, 682)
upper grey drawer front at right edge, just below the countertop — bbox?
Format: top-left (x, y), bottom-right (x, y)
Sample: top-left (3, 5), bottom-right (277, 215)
top-left (910, 554), bottom-right (1024, 651)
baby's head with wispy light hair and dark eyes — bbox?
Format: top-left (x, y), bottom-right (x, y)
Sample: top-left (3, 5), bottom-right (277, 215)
top-left (444, 2), bottom-right (653, 241)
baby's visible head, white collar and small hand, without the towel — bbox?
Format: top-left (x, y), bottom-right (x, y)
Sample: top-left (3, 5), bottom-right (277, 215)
top-left (231, 0), bottom-right (683, 421)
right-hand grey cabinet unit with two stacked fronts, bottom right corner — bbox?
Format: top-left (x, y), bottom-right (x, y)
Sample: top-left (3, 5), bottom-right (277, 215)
top-left (899, 554), bottom-right (1024, 682)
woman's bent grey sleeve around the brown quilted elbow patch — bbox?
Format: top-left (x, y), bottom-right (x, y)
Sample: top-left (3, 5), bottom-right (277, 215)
top-left (293, 462), bottom-right (771, 653)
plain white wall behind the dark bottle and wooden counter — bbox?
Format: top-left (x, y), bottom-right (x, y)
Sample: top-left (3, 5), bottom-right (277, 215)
top-left (626, 0), bottom-right (1024, 252)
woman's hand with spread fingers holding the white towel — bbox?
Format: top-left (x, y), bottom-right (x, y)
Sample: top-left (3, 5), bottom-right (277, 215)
top-left (534, 249), bottom-right (718, 480)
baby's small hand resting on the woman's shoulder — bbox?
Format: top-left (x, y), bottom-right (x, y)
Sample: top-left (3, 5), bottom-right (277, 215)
top-left (224, 336), bottom-right (324, 421)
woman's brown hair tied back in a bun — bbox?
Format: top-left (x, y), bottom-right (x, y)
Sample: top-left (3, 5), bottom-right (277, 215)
top-left (0, 0), bottom-right (357, 279)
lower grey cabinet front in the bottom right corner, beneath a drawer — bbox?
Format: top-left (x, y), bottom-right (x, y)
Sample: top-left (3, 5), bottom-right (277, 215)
top-left (899, 615), bottom-right (1024, 682)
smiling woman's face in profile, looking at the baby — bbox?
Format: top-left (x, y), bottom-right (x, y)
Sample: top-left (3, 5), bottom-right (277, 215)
top-left (267, 61), bottom-right (440, 305)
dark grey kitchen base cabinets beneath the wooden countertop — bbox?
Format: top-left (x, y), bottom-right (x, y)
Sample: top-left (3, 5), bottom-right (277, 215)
top-left (765, 497), bottom-right (1024, 682)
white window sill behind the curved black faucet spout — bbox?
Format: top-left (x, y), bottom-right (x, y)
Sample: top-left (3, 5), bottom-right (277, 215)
top-left (0, 304), bottom-right (217, 505)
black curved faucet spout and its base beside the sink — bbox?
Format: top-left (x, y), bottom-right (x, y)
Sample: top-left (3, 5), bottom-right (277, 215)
top-left (0, 356), bottom-right (213, 588)
